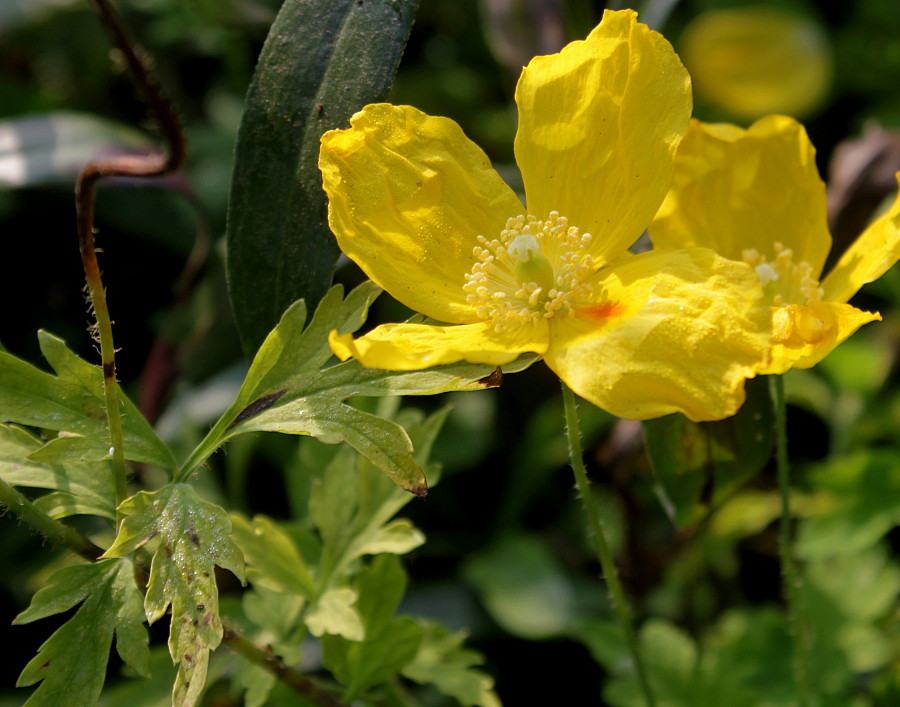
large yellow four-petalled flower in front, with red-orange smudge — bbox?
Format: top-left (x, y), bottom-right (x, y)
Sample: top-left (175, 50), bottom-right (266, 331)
top-left (319, 11), bottom-right (769, 420)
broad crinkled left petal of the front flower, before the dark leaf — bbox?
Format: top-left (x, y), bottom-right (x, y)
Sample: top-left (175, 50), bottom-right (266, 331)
top-left (319, 103), bottom-right (524, 323)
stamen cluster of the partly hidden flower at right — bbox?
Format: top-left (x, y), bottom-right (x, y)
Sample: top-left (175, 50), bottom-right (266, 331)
top-left (741, 243), bottom-right (837, 346)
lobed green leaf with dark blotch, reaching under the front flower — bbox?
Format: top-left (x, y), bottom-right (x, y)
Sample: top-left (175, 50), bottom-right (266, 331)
top-left (185, 282), bottom-right (534, 495)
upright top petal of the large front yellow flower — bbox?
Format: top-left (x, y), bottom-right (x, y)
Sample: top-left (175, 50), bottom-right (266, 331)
top-left (516, 10), bottom-right (691, 263)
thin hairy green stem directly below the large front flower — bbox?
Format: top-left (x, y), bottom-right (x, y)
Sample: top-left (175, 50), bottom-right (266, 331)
top-left (560, 381), bottom-right (656, 707)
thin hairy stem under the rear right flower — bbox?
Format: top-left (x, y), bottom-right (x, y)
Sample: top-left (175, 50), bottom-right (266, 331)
top-left (769, 376), bottom-right (810, 707)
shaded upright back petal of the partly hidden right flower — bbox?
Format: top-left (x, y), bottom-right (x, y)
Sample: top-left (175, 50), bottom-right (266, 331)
top-left (650, 116), bottom-right (831, 277)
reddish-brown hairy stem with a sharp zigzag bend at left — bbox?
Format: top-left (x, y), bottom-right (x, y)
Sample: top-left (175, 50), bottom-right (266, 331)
top-left (75, 0), bottom-right (185, 525)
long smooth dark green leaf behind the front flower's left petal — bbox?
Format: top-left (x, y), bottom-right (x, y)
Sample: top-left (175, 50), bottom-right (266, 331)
top-left (226, 0), bottom-right (418, 358)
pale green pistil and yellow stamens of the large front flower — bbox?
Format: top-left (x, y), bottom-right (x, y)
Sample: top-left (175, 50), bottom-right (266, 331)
top-left (463, 211), bottom-right (596, 330)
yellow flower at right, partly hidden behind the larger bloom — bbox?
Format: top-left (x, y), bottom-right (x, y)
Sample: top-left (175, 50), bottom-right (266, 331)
top-left (650, 116), bottom-right (900, 373)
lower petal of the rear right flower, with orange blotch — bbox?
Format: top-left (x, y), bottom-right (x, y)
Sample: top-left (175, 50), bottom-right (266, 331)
top-left (760, 302), bottom-right (881, 373)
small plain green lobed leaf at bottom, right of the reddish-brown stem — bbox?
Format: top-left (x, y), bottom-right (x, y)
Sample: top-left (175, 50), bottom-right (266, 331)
top-left (321, 555), bottom-right (422, 703)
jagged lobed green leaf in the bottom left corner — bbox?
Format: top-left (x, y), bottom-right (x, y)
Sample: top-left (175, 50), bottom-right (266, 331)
top-left (13, 560), bottom-right (150, 707)
